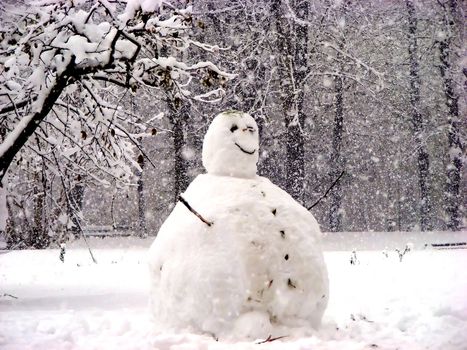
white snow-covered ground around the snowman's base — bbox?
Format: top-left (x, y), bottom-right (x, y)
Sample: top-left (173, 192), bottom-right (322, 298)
top-left (0, 232), bottom-right (467, 350)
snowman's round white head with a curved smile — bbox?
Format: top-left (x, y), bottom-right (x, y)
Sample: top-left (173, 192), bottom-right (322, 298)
top-left (203, 111), bottom-right (259, 178)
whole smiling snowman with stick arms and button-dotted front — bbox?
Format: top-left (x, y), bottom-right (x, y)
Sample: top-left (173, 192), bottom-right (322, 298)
top-left (149, 111), bottom-right (329, 340)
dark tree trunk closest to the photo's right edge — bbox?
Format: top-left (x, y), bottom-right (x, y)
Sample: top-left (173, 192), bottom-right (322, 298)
top-left (439, 0), bottom-right (463, 231)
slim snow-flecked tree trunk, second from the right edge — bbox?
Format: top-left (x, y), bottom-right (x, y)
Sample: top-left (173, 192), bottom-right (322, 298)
top-left (406, 0), bottom-right (432, 231)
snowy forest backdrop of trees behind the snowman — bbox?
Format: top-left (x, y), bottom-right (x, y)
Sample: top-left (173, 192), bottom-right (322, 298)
top-left (0, 0), bottom-right (467, 248)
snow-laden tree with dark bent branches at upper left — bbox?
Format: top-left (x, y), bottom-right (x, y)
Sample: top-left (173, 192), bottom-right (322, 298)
top-left (0, 0), bottom-right (233, 246)
